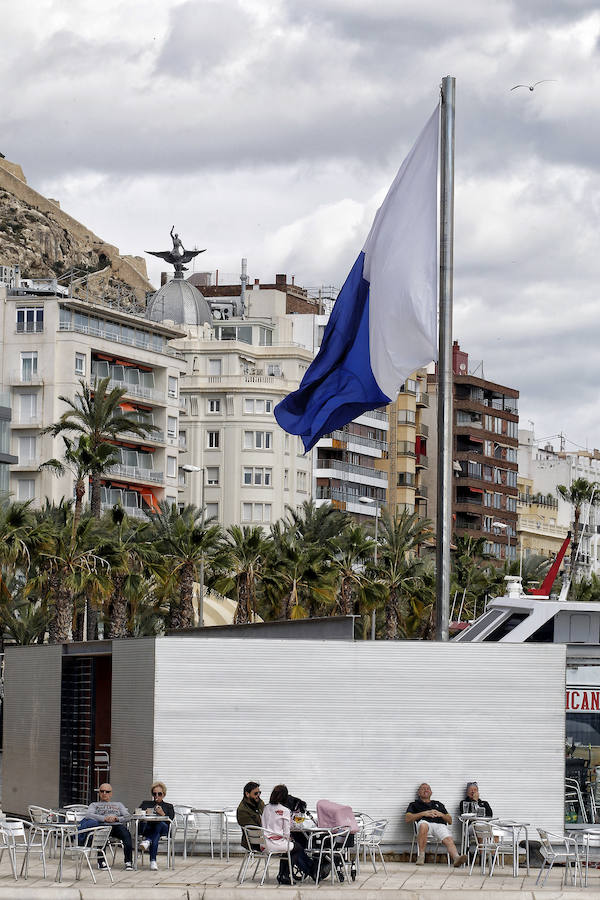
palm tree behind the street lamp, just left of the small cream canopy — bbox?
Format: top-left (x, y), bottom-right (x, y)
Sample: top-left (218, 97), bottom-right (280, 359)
top-left (151, 500), bottom-right (220, 628)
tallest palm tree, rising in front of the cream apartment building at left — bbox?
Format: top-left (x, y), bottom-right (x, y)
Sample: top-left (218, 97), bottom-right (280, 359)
top-left (43, 378), bottom-right (156, 518)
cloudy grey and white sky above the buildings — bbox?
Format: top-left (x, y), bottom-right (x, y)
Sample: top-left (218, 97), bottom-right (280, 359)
top-left (0, 0), bottom-right (600, 449)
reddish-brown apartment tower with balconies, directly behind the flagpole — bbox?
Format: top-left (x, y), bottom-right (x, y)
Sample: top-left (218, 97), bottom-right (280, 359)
top-left (424, 341), bottom-right (519, 560)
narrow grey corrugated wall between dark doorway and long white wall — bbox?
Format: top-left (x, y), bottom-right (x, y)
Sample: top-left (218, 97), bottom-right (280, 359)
top-left (110, 638), bottom-right (156, 810)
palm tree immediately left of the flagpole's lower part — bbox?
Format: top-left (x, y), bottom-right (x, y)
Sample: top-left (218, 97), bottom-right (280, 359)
top-left (376, 510), bottom-right (431, 640)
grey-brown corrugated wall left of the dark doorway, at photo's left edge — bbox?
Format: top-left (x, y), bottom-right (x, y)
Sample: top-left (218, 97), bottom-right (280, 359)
top-left (2, 644), bottom-right (62, 815)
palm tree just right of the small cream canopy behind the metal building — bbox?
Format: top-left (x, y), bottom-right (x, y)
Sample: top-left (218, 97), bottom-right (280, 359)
top-left (212, 525), bottom-right (270, 625)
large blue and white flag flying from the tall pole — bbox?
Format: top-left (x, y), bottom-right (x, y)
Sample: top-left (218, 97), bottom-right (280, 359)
top-left (275, 106), bottom-right (439, 450)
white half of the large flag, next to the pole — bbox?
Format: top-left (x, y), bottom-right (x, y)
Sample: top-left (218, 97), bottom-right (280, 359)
top-left (364, 106), bottom-right (439, 400)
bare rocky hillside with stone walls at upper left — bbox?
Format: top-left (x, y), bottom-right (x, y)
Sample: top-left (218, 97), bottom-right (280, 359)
top-left (0, 159), bottom-right (154, 303)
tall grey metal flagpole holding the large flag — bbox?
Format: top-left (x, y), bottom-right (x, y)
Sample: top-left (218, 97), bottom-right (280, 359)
top-left (436, 75), bottom-right (456, 641)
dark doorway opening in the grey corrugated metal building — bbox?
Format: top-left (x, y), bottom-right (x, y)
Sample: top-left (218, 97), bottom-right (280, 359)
top-left (60, 656), bottom-right (112, 806)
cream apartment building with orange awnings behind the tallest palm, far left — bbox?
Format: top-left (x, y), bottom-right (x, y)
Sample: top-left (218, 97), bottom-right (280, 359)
top-left (0, 267), bottom-right (185, 517)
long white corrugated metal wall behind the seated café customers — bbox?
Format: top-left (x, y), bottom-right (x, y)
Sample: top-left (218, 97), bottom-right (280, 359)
top-left (152, 636), bottom-right (565, 845)
